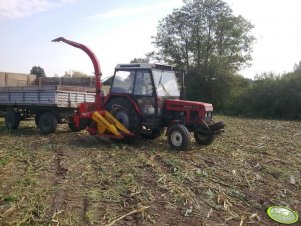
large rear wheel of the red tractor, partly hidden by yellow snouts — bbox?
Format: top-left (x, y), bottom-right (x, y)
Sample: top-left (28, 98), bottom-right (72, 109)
top-left (106, 97), bottom-right (141, 143)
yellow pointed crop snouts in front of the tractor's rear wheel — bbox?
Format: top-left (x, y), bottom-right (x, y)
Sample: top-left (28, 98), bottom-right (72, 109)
top-left (92, 111), bottom-right (133, 137)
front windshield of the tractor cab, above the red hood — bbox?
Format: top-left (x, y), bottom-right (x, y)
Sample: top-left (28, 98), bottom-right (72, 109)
top-left (153, 70), bottom-right (180, 97)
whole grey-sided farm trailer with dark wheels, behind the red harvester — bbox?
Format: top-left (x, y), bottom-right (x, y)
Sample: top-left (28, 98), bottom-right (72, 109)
top-left (0, 81), bottom-right (95, 134)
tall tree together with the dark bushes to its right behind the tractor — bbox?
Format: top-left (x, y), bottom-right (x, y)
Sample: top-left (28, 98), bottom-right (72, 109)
top-left (146, 0), bottom-right (301, 119)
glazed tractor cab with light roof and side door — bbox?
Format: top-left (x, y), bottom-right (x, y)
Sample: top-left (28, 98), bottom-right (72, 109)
top-left (110, 63), bottom-right (180, 116)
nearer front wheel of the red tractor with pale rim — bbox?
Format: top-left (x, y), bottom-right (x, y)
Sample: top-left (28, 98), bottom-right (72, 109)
top-left (167, 124), bottom-right (190, 151)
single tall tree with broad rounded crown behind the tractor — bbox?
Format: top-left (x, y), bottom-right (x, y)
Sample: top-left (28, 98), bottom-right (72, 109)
top-left (152, 0), bottom-right (255, 108)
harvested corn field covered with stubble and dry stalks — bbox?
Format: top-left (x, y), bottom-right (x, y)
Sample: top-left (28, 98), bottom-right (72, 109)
top-left (0, 116), bottom-right (301, 226)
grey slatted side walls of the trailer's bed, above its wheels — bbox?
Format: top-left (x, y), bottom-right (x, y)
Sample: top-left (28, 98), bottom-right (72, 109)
top-left (0, 85), bottom-right (95, 108)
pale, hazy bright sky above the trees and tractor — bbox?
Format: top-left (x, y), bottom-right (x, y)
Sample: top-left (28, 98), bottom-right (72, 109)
top-left (0, 0), bottom-right (301, 78)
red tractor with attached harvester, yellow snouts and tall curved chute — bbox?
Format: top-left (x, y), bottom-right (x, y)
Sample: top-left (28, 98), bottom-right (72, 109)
top-left (53, 38), bottom-right (224, 150)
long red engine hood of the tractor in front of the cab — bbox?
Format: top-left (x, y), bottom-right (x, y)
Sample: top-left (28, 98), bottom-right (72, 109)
top-left (166, 100), bottom-right (213, 112)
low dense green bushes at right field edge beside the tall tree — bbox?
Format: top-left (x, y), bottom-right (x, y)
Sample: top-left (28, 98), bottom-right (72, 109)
top-left (236, 71), bottom-right (301, 119)
